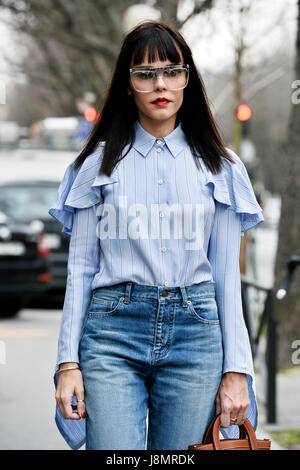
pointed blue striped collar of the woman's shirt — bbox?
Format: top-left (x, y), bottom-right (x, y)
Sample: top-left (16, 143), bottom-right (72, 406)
top-left (133, 119), bottom-right (187, 158)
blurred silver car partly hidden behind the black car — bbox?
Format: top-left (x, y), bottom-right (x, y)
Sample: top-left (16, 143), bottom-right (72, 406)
top-left (0, 180), bottom-right (69, 308)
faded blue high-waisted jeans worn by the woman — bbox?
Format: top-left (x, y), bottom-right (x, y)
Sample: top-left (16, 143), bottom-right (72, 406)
top-left (79, 281), bottom-right (223, 450)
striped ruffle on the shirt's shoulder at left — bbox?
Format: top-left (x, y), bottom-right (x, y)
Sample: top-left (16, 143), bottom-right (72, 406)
top-left (48, 142), bottom-right (118, 236)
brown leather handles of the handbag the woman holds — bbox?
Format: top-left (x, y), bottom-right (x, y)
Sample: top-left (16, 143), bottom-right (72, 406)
top-left (203, 413), bottom-right (257, 450)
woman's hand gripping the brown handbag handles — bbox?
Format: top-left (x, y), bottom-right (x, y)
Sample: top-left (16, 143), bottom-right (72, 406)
top-left (215, 372), bottom-right (250, 428)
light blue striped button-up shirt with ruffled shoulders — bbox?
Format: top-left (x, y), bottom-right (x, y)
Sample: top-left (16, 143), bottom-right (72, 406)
top-left (49, 120), bottom-right (264, 449)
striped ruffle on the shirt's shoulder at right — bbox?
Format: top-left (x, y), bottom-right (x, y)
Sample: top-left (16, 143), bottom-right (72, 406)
top-left (203, 148), bottom-right (265, 236)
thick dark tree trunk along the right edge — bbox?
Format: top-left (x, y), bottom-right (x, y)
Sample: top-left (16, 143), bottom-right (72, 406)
top-left (273, 0), bottom-right (300, 367)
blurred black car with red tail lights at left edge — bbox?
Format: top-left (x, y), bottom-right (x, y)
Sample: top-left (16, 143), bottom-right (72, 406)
top-left (0, 212), bottom-right (52, 317)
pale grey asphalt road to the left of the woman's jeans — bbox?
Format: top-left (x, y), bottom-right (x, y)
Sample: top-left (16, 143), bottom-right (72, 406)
top-left (0, 309), bottom-right (69, 450)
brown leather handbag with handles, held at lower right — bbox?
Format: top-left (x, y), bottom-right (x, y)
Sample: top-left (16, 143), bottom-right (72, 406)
top-left (188, 413), bottom-right (271, 450)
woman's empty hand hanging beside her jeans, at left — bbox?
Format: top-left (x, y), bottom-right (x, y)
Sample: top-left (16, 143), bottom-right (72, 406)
top-left (55, 362), bottom-right (86, 419)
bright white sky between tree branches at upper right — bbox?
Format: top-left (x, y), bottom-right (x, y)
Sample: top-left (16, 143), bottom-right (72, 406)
top-left (180, 0), bottom-right (297, 74)
